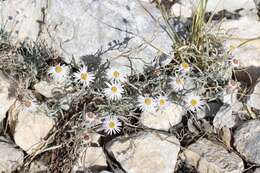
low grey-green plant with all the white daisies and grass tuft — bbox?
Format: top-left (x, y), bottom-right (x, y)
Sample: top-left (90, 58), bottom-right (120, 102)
top-left (0, 0), bottom-right (244, 171)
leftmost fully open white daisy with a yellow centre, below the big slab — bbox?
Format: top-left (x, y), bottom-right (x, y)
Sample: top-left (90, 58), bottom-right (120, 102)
top-left (48, 64), bottom-right (69, 81)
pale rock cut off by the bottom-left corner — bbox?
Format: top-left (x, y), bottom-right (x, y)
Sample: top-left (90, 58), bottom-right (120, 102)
top-left (0, 138), bottom-right (24, 173)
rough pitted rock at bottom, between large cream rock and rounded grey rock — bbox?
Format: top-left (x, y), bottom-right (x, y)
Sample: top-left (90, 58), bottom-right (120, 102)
top-left (181, 139), bottom-right (244, 173)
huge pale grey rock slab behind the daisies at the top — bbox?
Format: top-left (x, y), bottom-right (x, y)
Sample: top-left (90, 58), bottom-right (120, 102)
top-left (0, 0), bottom-right (172, 72)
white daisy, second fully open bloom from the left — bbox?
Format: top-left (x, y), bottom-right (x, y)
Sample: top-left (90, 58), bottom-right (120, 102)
top-left (73, 66), bottom-right (95, 86)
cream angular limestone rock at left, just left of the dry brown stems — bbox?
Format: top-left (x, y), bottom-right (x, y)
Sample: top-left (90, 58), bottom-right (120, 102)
top-left (11, 103), bottom-right (54, 154)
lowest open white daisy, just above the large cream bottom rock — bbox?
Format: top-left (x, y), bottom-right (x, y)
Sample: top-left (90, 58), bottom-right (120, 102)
top-left (103, 116), bottom-right (122, 135)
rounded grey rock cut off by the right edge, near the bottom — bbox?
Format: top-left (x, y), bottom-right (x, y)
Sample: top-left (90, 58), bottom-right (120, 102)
top-left (234, 120), bottom-right (260, 164)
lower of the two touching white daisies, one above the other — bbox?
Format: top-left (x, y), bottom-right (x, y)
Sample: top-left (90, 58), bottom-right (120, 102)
top-left (104, 82), bottom-right (124, 100)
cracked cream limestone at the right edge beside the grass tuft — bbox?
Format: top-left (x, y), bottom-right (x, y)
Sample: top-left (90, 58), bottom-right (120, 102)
top-left (221, 16), bottom-right (260, 67)
